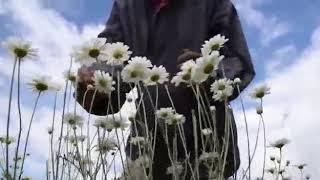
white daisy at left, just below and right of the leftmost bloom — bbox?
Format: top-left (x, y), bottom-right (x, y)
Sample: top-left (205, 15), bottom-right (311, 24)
top-left (27, 76), bottom-right (56, 92)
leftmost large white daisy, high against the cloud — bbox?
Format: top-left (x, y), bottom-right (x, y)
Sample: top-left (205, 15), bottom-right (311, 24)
top-left (2, 37), bottom-right (38, 60)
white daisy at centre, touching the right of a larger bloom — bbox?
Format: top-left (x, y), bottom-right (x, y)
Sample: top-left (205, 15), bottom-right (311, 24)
top-left (144, 66), bottom-right (169, 86)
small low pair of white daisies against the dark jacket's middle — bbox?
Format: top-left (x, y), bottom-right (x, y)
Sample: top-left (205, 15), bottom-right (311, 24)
top-left (156, 107), bottom-right (186, 125)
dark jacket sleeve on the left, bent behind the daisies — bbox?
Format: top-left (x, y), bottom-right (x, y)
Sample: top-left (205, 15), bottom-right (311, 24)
top-left (76, 1), bottom-right (130, 116)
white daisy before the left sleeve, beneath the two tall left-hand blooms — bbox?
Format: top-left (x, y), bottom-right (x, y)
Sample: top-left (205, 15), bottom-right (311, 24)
top-left (93, 71), bottom-right (115, 94)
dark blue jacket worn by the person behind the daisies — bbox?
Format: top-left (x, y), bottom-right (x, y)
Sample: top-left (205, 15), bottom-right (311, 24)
top-left (78, 0), bottom-right (255, 180)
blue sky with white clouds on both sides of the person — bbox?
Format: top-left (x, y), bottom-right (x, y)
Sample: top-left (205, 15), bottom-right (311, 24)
top-left (0, 0), bottom-right (320, 179)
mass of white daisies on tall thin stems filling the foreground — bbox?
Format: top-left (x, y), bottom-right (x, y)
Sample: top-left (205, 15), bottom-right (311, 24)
top-left (0, 35), bottom-right (310, 180)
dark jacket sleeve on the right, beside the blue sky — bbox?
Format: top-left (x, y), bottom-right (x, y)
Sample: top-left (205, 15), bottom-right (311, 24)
top-left (210, 0), bottom-right (255, 101)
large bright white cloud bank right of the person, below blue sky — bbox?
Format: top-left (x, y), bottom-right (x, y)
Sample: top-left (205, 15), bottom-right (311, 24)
top-left (237, 27), bottom-right (320, 177)
